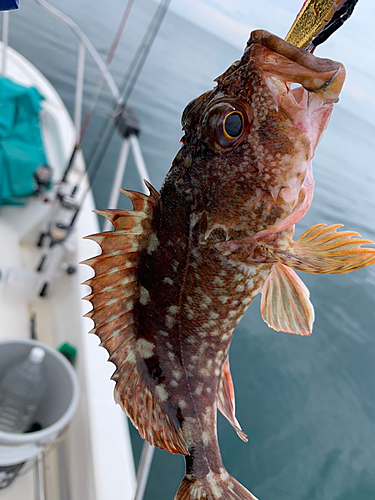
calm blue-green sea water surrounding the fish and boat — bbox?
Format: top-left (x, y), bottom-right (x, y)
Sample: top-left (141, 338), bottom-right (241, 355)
top-left (5, 0), bottom-right (375, 500)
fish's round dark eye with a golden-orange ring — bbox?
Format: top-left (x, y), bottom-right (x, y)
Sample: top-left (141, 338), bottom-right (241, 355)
top-left (202, 99), bottom-right (253, 152)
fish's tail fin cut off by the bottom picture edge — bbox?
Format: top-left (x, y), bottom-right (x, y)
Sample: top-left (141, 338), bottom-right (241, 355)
top-left (174, 468), bottom-right (258, 500)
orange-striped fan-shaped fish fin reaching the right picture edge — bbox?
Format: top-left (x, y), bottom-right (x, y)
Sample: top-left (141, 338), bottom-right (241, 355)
top-left (263, 224), bottom-right (375, 274)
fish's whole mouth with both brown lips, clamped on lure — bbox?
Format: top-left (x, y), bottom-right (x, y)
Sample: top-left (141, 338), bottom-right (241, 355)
top-left (248, 30), bottom-right (345, 100)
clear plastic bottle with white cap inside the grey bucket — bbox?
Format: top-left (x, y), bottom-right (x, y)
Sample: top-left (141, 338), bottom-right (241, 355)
top-left (0, 347), bottom-right (47, 433)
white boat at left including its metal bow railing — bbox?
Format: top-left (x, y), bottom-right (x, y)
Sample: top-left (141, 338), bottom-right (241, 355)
top-left (0, 0), bottom-right (144, 500)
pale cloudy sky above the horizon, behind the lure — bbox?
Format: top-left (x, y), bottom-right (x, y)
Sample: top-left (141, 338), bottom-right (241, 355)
top-left (170, 0), bottom-right (375, 125)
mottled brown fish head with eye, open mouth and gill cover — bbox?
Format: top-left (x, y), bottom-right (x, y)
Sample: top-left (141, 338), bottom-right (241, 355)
top-left (165, 30), bottom-right (345, 244)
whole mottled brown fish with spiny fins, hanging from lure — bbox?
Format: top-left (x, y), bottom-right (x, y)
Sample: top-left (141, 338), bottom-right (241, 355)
top-left (85, 30), bottom-right (375, 500)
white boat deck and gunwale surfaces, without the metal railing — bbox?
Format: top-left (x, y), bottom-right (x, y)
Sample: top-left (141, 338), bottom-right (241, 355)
top-left (0, 42), bottom-right (135, 500)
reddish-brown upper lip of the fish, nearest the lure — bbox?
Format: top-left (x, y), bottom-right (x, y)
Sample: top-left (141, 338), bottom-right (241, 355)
top-left (248, 30), bottom-right (342, 73)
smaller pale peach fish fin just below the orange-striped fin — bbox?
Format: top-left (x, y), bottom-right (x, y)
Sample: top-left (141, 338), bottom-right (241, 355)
top-left (260, 263), bottom-right (314, 335)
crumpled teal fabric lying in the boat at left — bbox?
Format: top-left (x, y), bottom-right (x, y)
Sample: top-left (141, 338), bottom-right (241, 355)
top-left (0, 78), bottom-right (46, 206)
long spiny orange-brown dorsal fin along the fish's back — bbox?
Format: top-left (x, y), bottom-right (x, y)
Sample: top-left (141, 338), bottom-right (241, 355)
top-left (83, 185), bottom-right (188, 455)
